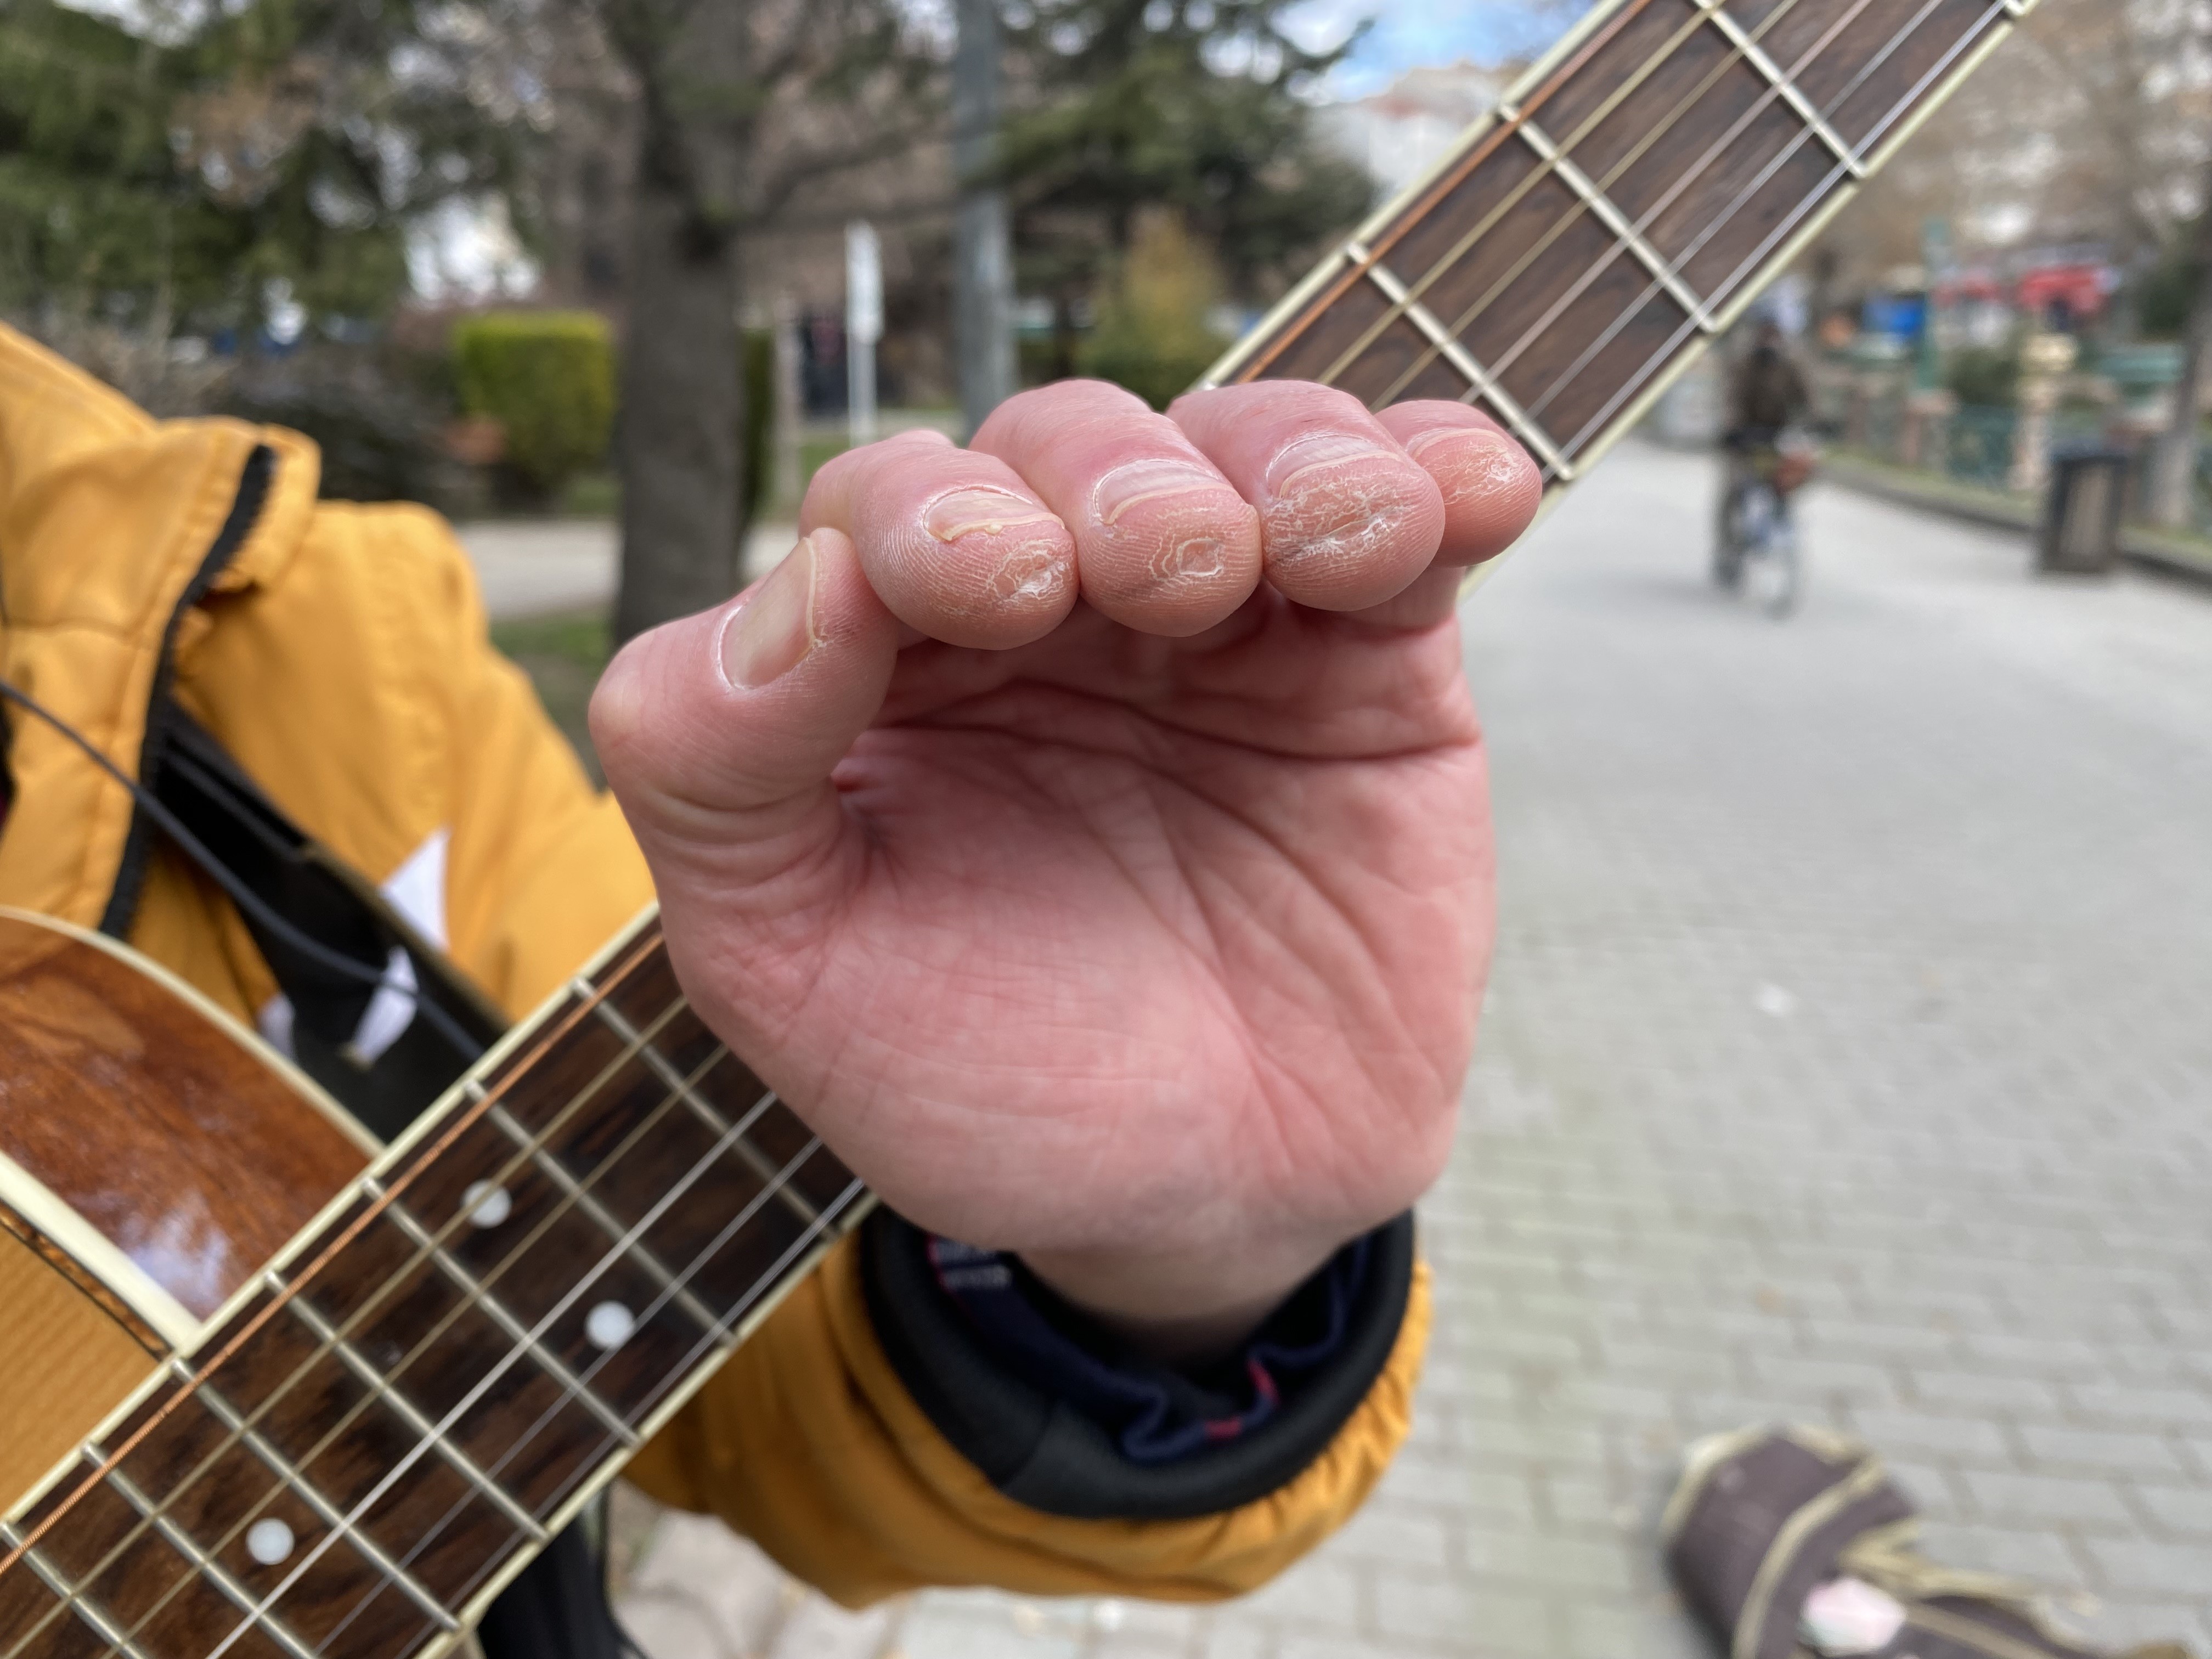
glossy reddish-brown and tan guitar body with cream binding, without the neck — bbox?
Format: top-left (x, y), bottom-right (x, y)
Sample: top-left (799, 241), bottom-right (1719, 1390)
top-left (0, 911), bottom-right (376, 1515)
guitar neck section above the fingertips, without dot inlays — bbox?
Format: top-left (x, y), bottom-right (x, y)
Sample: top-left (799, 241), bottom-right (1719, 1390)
top-left (1201, 0), bottom-right (2037, 491)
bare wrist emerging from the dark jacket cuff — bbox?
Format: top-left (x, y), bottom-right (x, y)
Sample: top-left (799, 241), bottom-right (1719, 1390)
top-left (1020, 1237), bottom-right (1345, 1365)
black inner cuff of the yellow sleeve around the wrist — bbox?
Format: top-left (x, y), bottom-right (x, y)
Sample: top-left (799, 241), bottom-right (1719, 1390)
top-left (858, 1210), bottom-right (1413, 1520)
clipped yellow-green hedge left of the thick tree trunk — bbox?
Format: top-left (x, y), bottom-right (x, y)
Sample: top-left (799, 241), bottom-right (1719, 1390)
top-left (454, 312), bottom-right (615, 491)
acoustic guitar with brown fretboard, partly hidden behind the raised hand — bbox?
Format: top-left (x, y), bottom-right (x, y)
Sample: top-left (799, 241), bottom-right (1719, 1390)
top-left (0, 0), bottom-right (2035, 1659)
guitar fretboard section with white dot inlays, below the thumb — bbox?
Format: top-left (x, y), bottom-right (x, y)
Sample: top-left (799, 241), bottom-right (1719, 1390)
top-left (0, 918), bottom-right (870, 1659)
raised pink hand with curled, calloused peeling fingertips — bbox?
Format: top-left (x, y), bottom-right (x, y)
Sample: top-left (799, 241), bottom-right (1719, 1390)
top-left (591, 381), bottom-right (1539, 1356)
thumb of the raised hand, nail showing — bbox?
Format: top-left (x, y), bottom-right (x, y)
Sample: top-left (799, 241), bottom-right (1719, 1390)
top-left (591, 529), bottom-right (898, 920)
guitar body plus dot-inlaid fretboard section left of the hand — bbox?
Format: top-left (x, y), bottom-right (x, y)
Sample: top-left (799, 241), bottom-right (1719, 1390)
top-left (0, 911), bottom-right (870, 1659)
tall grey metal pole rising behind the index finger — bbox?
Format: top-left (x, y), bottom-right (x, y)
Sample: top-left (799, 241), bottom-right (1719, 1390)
top-left (953, 0), bottom-right (1015, 433)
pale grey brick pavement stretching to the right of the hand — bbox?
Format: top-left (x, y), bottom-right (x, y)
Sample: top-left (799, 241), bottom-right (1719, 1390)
top-left (606, 447), bottom-right (2212, 1659)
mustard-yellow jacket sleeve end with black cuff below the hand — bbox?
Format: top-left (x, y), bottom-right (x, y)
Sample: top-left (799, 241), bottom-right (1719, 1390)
top-left (630, 1215), bottom-right (1429, 1606)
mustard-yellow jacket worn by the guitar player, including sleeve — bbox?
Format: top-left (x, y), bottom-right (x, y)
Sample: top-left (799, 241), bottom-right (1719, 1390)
top-left (0, 328), bottom-right (1427, 1604)
